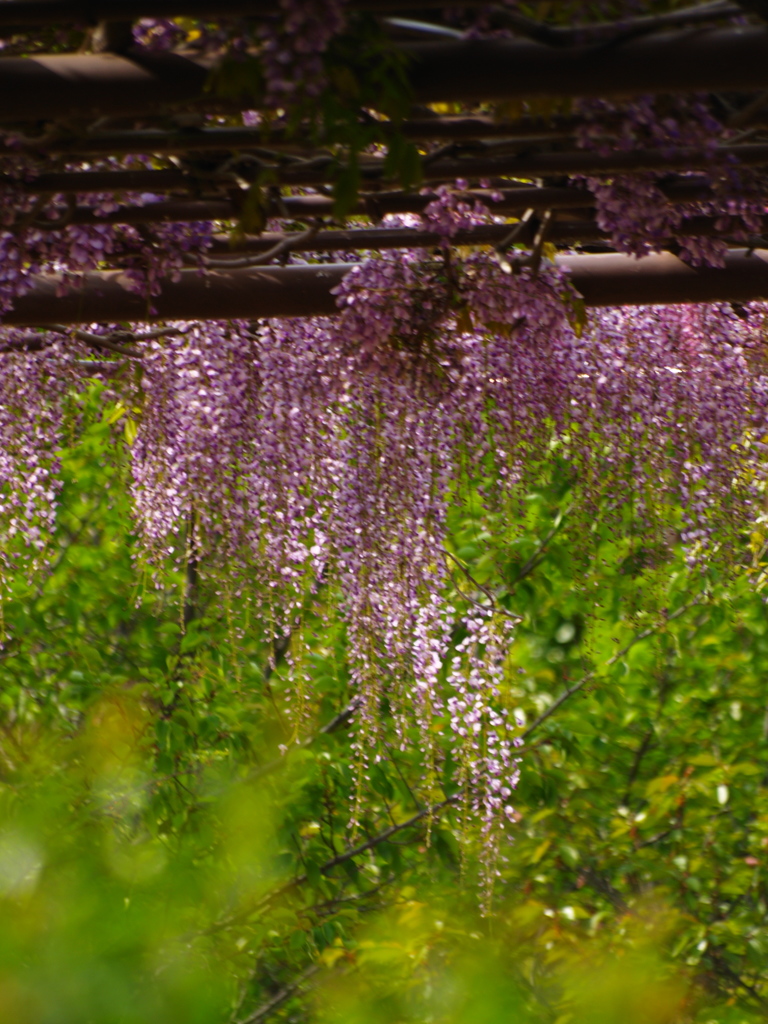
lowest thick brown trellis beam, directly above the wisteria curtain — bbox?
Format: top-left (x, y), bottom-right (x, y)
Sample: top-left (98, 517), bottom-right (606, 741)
top-left (4, 250), bottom-right (768, 326)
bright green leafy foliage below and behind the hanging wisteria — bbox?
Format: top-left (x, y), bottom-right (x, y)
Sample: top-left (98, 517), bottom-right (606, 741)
top-left (0, 392), bottom-right (768, 1024)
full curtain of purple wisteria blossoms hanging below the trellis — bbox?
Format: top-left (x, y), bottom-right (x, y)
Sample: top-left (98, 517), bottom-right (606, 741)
top-left (0, 239), bottom-right (768, 899)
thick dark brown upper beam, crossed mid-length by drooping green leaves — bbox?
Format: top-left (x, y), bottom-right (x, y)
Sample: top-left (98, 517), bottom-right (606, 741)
top-left (0, 26), bottom-right (768, 123)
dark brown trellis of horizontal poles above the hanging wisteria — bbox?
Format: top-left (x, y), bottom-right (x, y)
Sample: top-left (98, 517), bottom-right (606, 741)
top-left (0, 0), bottom-right (768, 324)
